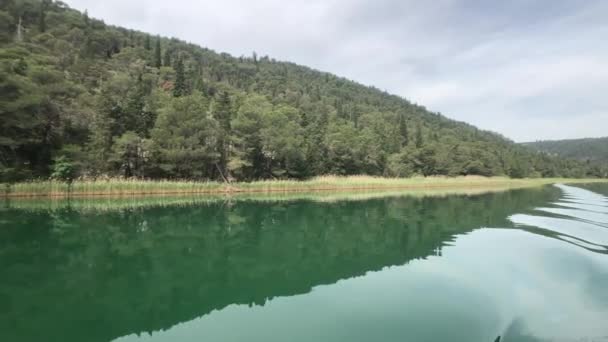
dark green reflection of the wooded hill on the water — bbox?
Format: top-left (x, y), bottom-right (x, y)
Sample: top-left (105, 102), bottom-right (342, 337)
top-left (0, 188), bottom-right (559, 341)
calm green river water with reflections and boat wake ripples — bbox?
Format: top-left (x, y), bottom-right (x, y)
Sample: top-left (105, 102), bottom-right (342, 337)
top-left (0, 185), bottom-right (608, 342)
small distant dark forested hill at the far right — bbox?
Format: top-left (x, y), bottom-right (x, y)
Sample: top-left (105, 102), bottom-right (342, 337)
top-left (523, 137), bottom-right (608, 163)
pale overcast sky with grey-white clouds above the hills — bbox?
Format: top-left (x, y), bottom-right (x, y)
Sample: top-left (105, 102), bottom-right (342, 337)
top-left (65, 0), bottom-right (608, 141)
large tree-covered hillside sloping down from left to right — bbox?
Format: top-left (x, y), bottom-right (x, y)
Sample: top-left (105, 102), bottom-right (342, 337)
top-left (0, 0), bottom-right (606, 182)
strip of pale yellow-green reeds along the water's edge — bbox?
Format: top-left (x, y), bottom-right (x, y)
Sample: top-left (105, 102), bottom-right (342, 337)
top-left (0, 176), bottom-right (608, 198)
